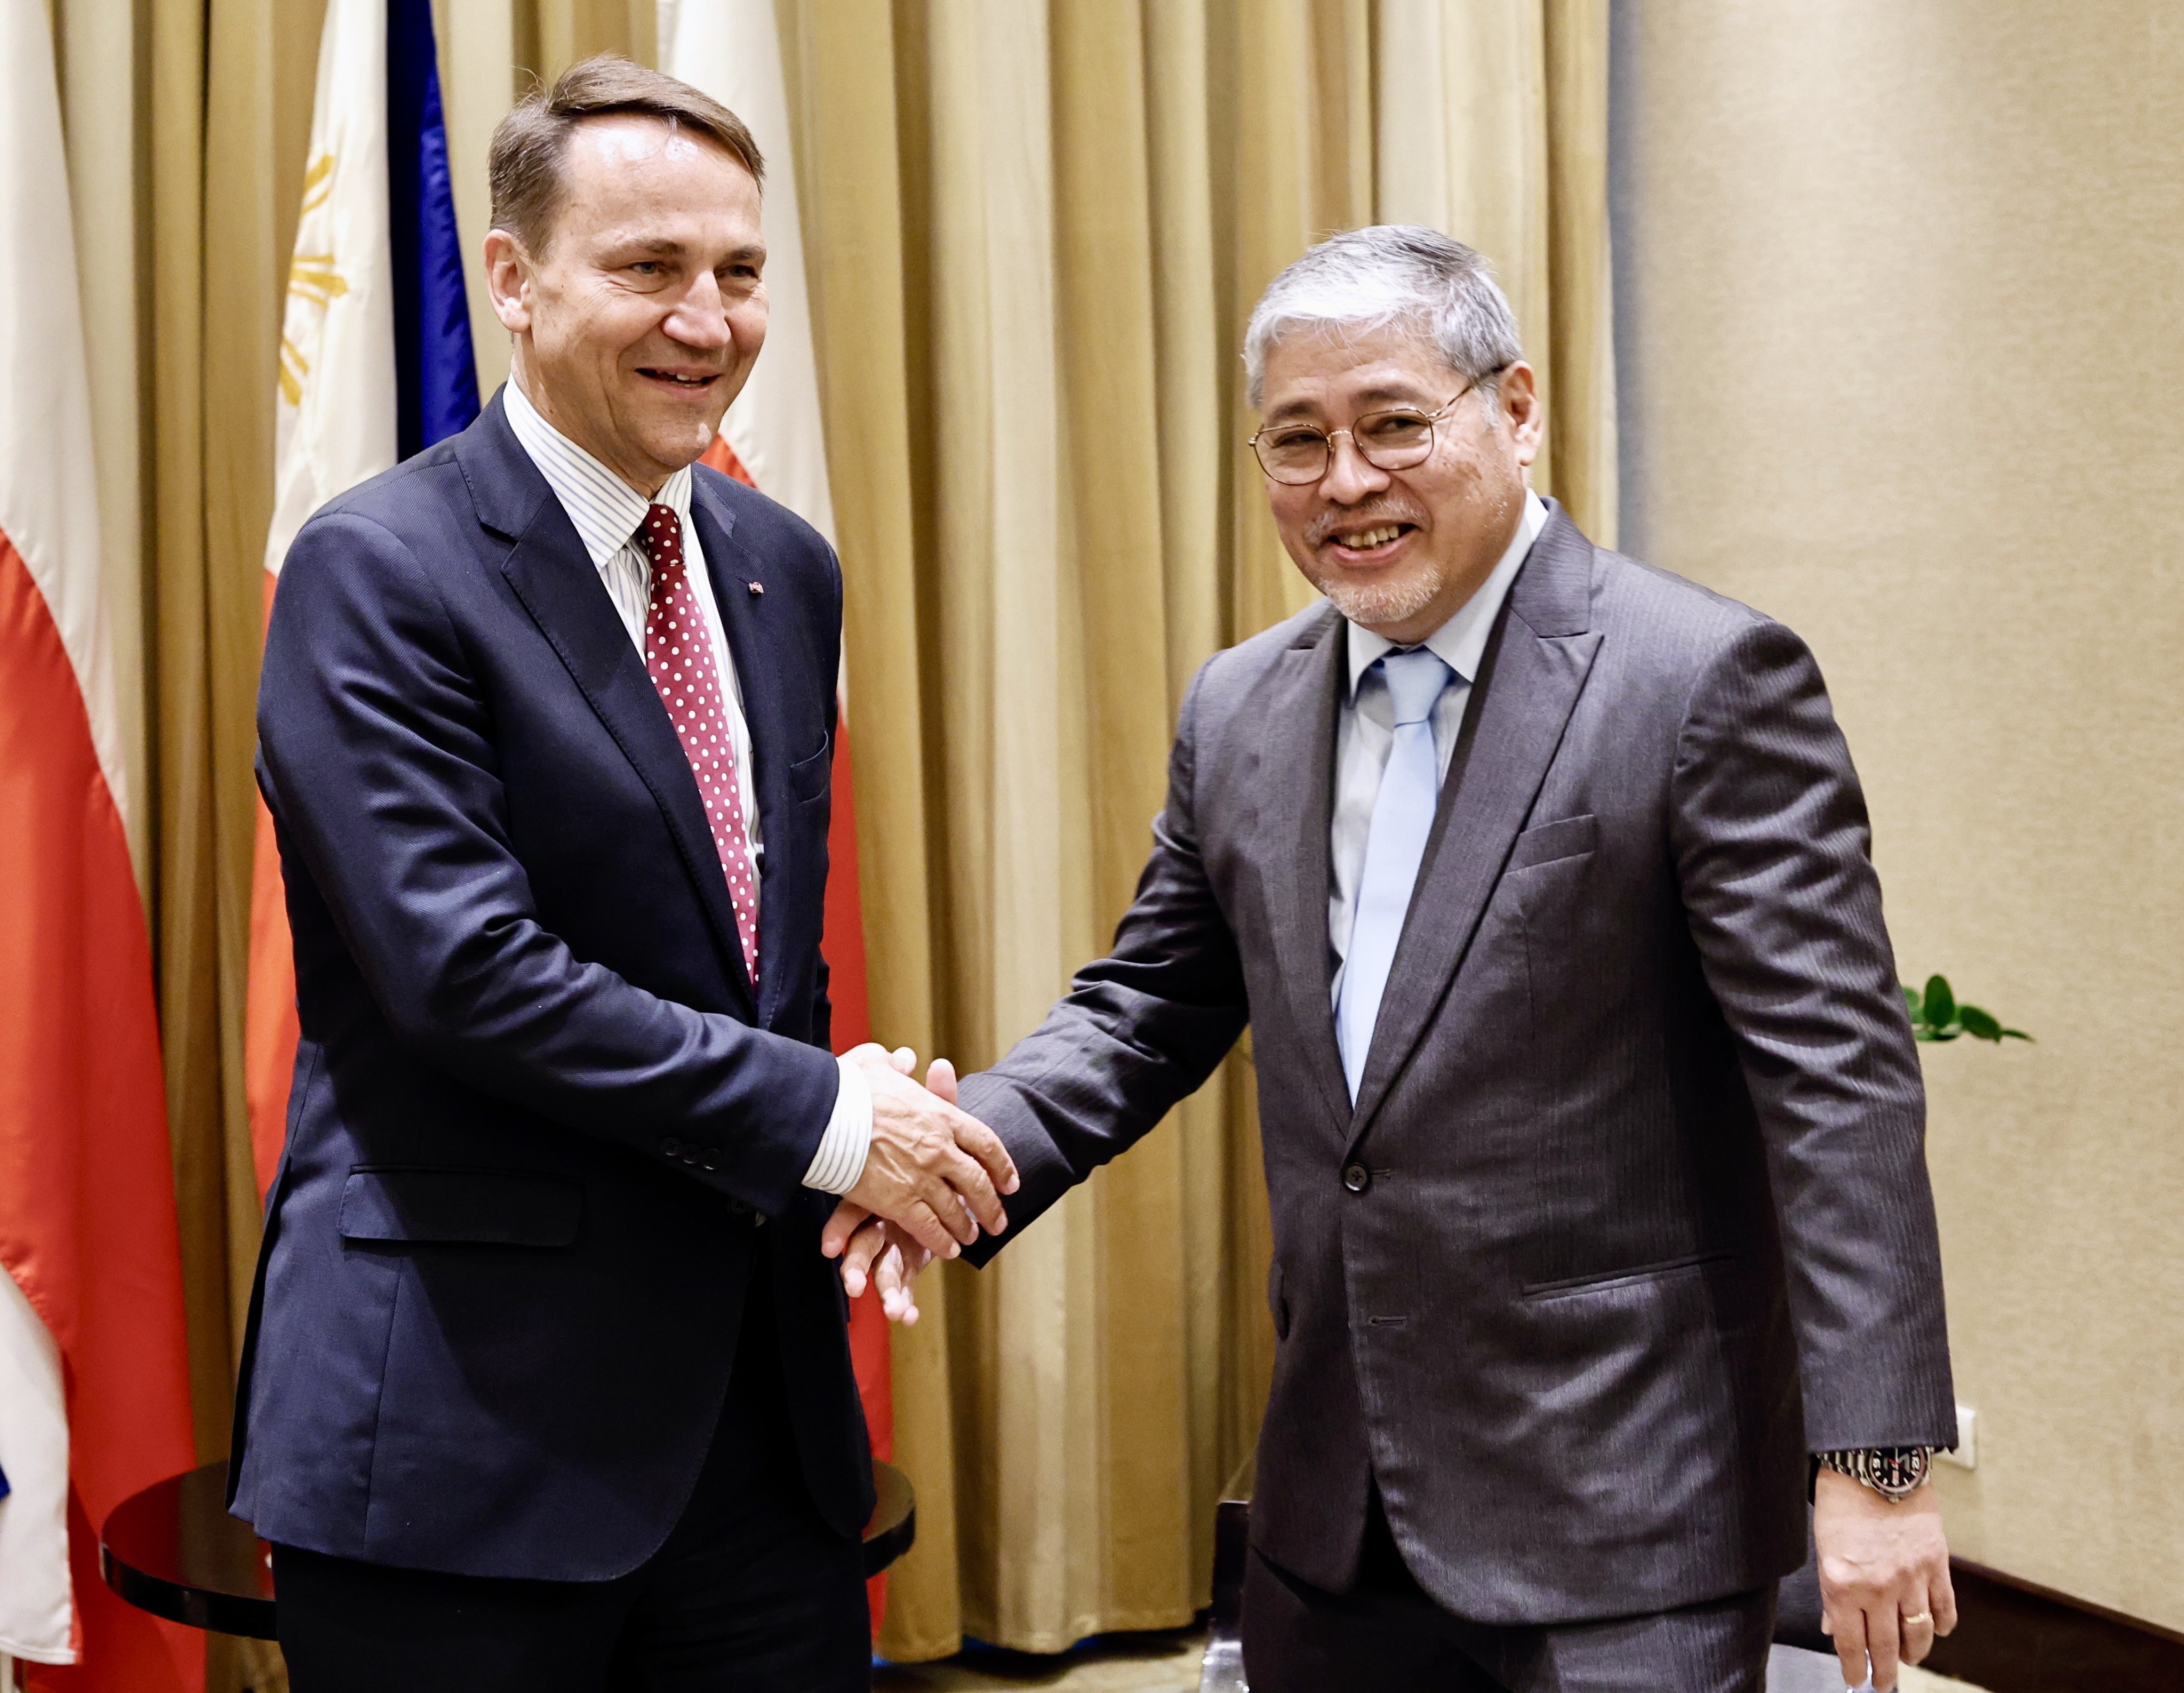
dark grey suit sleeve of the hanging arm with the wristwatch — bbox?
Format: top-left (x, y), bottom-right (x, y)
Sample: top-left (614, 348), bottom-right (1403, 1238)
top-left (1671, 623), bottom-right (1957, 1450)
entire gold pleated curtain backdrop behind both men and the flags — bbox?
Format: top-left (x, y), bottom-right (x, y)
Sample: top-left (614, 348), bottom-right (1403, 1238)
top-left (30, 0), bottom-right (1614, 1687)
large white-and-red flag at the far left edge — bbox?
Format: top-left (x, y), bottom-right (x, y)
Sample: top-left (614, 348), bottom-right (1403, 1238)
top-left (0, 4), bottom-right (205, 1693)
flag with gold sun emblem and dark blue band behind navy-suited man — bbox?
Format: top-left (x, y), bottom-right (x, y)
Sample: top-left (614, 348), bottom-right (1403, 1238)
top-left (243, 0), bottom-right (478, 1197)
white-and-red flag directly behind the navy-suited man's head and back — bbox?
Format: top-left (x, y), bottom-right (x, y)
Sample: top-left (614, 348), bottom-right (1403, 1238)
top-left (658, 0), bottom-right (895, 1636)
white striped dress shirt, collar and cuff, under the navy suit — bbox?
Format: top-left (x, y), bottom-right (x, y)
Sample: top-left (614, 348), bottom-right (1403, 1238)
top-left (502, 378), bottom-right (869, 1193)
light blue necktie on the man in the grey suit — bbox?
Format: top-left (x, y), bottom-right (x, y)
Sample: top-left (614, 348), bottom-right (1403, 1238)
top-left (1334, 647), bottom-right (1454, 1103)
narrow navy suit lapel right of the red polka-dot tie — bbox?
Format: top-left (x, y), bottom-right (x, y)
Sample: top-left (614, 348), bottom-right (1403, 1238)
top-left (690, 476), bottom-right (799, 1029)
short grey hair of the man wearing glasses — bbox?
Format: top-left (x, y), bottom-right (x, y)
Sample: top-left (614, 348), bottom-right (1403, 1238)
top-left (1243, 223), bottom-right (1524, 406)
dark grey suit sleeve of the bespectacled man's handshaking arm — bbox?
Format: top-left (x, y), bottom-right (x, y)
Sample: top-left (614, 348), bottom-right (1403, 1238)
top-left (961, 669), bottom-right (1247, 1265)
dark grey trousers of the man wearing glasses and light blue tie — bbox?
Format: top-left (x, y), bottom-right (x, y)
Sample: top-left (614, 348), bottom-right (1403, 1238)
top-left (1243, 1490), bottom-right (1773, 1693)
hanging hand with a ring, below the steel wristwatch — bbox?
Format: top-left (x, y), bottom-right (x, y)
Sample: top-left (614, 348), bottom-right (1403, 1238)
top-left (1813, 1470), bottom-right (1957, 1693)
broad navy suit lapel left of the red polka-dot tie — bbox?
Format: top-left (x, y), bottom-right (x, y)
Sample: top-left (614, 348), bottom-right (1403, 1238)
top-left (457, 396), bottom-right (756, 1012)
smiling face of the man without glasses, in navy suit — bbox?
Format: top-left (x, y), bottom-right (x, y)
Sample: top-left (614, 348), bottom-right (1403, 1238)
top-left (485, 116), bottom-right (766, 498)
